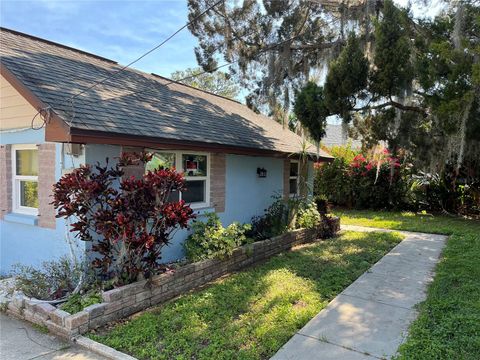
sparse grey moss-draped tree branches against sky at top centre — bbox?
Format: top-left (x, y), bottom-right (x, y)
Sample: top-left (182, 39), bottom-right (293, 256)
top-left (188, 0), bottom-right (380, 114)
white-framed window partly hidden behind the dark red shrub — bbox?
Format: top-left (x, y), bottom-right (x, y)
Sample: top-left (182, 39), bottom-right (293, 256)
top-left (146, 151), bottom-right (210, 208)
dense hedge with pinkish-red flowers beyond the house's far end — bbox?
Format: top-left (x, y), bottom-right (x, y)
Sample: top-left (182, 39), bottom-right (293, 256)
top-left (314, 146), bottom-right (480, 216)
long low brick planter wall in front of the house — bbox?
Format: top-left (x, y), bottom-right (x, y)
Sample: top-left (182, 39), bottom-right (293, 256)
top-left (7, 218), bottom-right (340, 338)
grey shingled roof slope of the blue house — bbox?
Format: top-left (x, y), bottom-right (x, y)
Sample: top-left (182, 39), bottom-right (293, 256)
top-left (0, 28), bottom-right (331, 158)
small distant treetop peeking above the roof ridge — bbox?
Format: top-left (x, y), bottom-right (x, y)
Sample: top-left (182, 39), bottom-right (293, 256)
top-left (170, 68), bottom-right (240, 99)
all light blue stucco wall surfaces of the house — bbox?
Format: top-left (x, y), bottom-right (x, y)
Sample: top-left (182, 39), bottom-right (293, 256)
top-left (0, 137), bottom-right (313, 273)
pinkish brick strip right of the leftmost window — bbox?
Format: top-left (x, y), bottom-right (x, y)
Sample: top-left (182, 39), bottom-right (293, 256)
top-left (38, 143), bottom-right (56, 229)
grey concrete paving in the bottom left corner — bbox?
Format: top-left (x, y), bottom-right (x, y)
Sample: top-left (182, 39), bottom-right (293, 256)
top-left (0, 314), bottom-right (105, 360)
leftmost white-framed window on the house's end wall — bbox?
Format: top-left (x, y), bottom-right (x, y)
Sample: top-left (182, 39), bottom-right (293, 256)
top-left (12, 145), bottom-right (38, 215)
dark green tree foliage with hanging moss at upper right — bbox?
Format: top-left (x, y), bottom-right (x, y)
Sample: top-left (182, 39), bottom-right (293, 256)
top-left (295, 0), bottom-right (480, 202)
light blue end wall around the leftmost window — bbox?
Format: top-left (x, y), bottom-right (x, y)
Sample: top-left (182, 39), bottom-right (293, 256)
top-left (0, 129), bottom-right (84, 274)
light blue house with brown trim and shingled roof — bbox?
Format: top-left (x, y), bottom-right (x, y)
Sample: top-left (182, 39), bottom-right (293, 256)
top-left (0, 29), bottom-right (331, 272)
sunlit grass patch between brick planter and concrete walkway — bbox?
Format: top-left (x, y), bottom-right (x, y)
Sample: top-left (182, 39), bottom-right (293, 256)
top-left (90, 232), bottom-right (401, 359)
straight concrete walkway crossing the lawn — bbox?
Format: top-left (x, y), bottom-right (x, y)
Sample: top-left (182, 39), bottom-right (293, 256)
top-left (272, 226), bottom-right (447, 360)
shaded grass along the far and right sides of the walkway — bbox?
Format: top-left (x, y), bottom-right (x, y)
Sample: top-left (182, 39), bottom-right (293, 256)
top-left (337, 211), bottom-right (480, 360)
